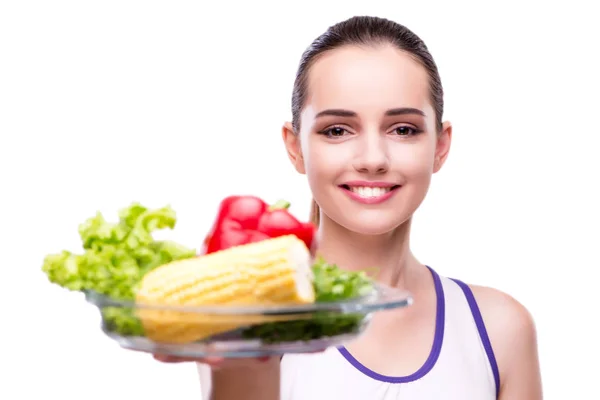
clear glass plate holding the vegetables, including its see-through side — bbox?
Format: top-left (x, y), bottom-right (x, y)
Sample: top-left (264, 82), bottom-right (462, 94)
top-left (85, 283), bottom-right (412, 358)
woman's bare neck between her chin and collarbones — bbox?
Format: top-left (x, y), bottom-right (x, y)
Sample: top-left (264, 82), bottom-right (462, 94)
top-left (317, 215), bottom-right (418, 288)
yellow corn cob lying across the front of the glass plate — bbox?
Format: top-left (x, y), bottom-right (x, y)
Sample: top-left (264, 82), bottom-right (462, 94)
top-left (136, 235), bottom-right (315, 343)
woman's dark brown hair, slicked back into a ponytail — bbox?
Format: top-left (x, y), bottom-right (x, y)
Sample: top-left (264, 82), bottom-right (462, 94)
top-left (292, 16), bottom-right (444, 225)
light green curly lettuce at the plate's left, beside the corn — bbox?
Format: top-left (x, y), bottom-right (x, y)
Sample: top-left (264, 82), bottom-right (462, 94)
top-left (42, 203), bottom-right (196, 334)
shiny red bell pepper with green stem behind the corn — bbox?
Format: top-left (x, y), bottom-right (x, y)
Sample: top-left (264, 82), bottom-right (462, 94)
top-left (204, 196), bottom-right (316, 254)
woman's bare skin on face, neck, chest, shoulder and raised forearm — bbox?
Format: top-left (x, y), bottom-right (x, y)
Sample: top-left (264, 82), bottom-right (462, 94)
top-left (151, 42), bottom-right (542, 400)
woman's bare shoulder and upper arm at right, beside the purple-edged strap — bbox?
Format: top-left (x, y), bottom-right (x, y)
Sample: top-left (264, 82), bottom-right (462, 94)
top-left (471, 286), bottom-right (543, 400)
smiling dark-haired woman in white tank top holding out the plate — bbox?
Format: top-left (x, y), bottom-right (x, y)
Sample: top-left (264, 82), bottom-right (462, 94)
top-left (152, 17), bottom-right (542, 400)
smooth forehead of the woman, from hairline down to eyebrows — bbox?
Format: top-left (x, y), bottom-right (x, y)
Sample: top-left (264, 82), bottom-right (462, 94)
top-left (306, 45), bottom-right (433, 116)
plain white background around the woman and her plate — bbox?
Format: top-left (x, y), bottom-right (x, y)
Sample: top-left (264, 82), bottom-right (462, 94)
top-left (0, 0), bottom-right (600, 400)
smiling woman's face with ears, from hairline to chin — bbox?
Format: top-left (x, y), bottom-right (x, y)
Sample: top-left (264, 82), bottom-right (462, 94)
top-left (284, 46), bottom-right (451, 235)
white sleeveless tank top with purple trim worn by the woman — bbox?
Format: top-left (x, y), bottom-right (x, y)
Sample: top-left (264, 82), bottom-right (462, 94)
top-left (281, 268), bottom-right (499, 400)
